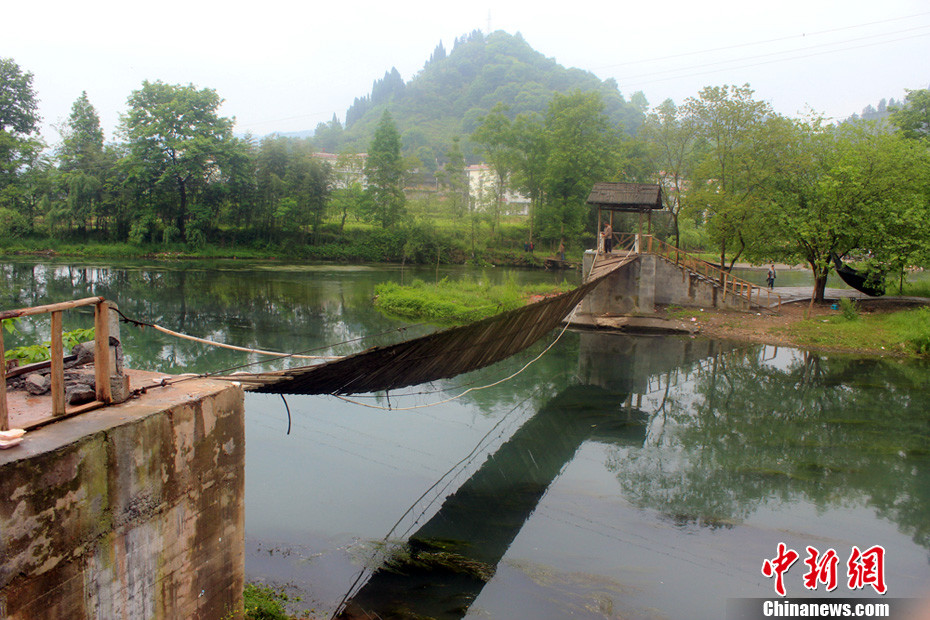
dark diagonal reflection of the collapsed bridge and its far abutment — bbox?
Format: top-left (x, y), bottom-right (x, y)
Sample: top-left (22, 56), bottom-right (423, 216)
top-left (340, 333), bottom-right (719, 618)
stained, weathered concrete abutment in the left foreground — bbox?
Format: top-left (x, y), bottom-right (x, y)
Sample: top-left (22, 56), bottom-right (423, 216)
top-left (0, 380), bottom-right (245, 620)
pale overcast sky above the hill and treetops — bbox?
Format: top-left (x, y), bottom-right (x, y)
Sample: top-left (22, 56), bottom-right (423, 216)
top-left (7, 0), bottom-right (930, 144)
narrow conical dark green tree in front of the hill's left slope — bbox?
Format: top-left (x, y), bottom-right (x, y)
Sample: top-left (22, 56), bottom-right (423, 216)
top-left (365, 110), bottom-right (405, 228)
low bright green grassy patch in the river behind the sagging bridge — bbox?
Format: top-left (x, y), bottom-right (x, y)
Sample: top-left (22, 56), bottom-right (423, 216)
top-left (375, 278), bottom-right (571, 325)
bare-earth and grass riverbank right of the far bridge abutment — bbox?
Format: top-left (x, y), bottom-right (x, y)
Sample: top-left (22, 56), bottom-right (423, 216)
top-left (656, 297), bottom-right (930, 358)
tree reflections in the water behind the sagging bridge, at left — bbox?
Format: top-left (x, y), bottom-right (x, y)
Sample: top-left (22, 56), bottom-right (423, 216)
top-left (2, 263), bottom-right (418, 372)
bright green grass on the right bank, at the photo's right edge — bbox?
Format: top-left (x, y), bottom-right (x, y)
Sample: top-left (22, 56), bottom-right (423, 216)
top-left (785, 308), bottom-right (930, 356)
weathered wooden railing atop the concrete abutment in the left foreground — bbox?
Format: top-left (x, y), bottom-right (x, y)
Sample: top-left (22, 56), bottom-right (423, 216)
top-left (0, 297), bottom-right (113, 431)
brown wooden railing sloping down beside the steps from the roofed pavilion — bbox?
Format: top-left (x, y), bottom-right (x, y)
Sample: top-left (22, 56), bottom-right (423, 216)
top-left (613, 233), bottom-right (781, 307)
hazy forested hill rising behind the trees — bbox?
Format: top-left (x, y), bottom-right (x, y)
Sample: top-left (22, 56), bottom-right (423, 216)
top-left (315, 31), bottom-right (646, 166)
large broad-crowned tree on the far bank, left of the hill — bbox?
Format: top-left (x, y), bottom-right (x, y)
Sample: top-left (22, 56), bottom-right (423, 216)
top-left (122, 81), bottom-right (243, 239)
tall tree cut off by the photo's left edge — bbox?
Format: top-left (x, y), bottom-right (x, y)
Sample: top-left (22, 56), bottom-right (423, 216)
top-left (0, 58), bottom-right (42, 216)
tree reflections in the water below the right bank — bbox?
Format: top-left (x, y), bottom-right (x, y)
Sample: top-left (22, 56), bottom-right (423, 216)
top-left (610, 348), bottom-right (930, 548)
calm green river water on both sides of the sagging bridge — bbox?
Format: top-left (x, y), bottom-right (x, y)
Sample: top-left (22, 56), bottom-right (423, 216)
top-left (0, 262), bottom-right (930, 619)
